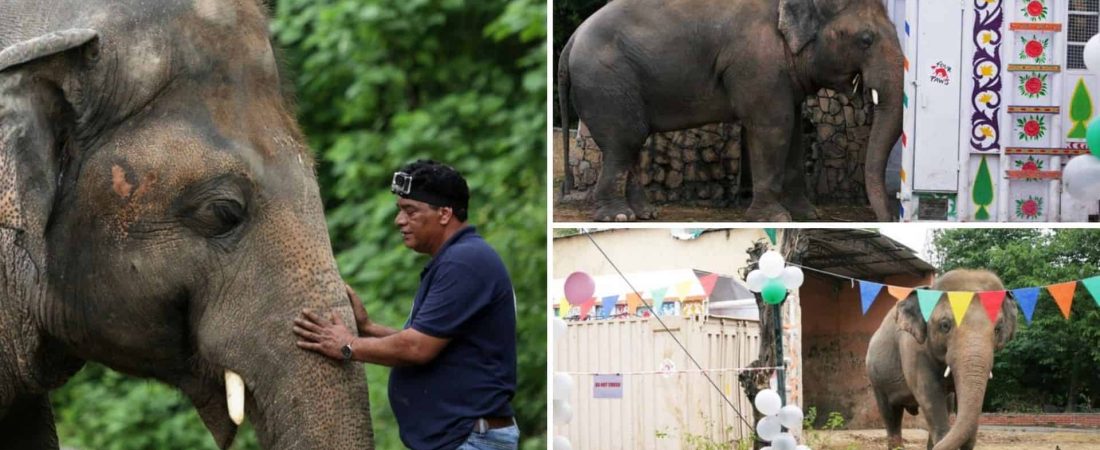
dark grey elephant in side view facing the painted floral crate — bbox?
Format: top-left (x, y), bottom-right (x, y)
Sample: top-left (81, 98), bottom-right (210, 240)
top-left (558, 0), bottom-right (902, 221)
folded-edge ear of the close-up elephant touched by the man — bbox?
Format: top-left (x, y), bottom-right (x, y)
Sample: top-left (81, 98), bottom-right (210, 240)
top-left (0, 29), bottom-right (97, 232)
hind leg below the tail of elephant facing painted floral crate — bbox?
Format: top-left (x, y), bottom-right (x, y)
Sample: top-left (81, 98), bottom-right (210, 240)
top-left (585, 100), bottom-right (649, 222)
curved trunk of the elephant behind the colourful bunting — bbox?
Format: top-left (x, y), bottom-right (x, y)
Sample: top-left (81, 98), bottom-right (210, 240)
top-left (933, 342), bottom-right (993, 450)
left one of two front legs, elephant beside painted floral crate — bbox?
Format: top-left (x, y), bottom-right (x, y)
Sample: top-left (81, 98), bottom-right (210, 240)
top-left (745, 119), bottom-right (792, 222)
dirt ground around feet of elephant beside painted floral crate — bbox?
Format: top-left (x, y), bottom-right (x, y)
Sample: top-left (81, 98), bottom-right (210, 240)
top-left (552, 132), bottom-right (875, 222)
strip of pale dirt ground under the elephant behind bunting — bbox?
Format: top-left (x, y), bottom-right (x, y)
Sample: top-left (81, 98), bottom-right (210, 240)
top-left (803, 426), bottom-right (1100, 450)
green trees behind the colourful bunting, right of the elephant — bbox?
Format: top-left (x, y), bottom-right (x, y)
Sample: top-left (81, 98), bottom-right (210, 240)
top-left (933, 229), bottom-right (1100, 411)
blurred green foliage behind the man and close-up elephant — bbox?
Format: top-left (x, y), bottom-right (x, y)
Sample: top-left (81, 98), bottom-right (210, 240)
top-left (53, 0), bottom-right (547, 450)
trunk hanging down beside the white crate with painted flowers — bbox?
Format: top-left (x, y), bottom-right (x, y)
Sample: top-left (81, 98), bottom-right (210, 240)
top-left (864, 69), bottom-right (903, 221)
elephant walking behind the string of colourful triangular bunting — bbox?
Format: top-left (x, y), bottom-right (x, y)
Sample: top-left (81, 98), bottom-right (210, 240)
top-left (867, 270), bottom-right (1016, 450)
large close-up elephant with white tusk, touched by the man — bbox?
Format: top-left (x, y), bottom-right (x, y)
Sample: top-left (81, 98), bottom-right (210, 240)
top-left (0, 0), bottom-right (373, 449)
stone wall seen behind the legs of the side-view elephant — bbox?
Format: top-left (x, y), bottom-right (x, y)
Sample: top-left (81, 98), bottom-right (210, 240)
top-left (568, 89), bottom-right (870, 207)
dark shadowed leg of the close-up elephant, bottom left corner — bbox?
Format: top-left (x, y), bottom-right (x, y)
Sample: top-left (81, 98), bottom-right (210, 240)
top-left (0, 394), bottom-right (57, 450)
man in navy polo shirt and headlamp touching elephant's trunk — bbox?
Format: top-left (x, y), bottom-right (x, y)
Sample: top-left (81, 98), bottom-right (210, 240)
top-left (294, 161), bottom-right (519, 450)
